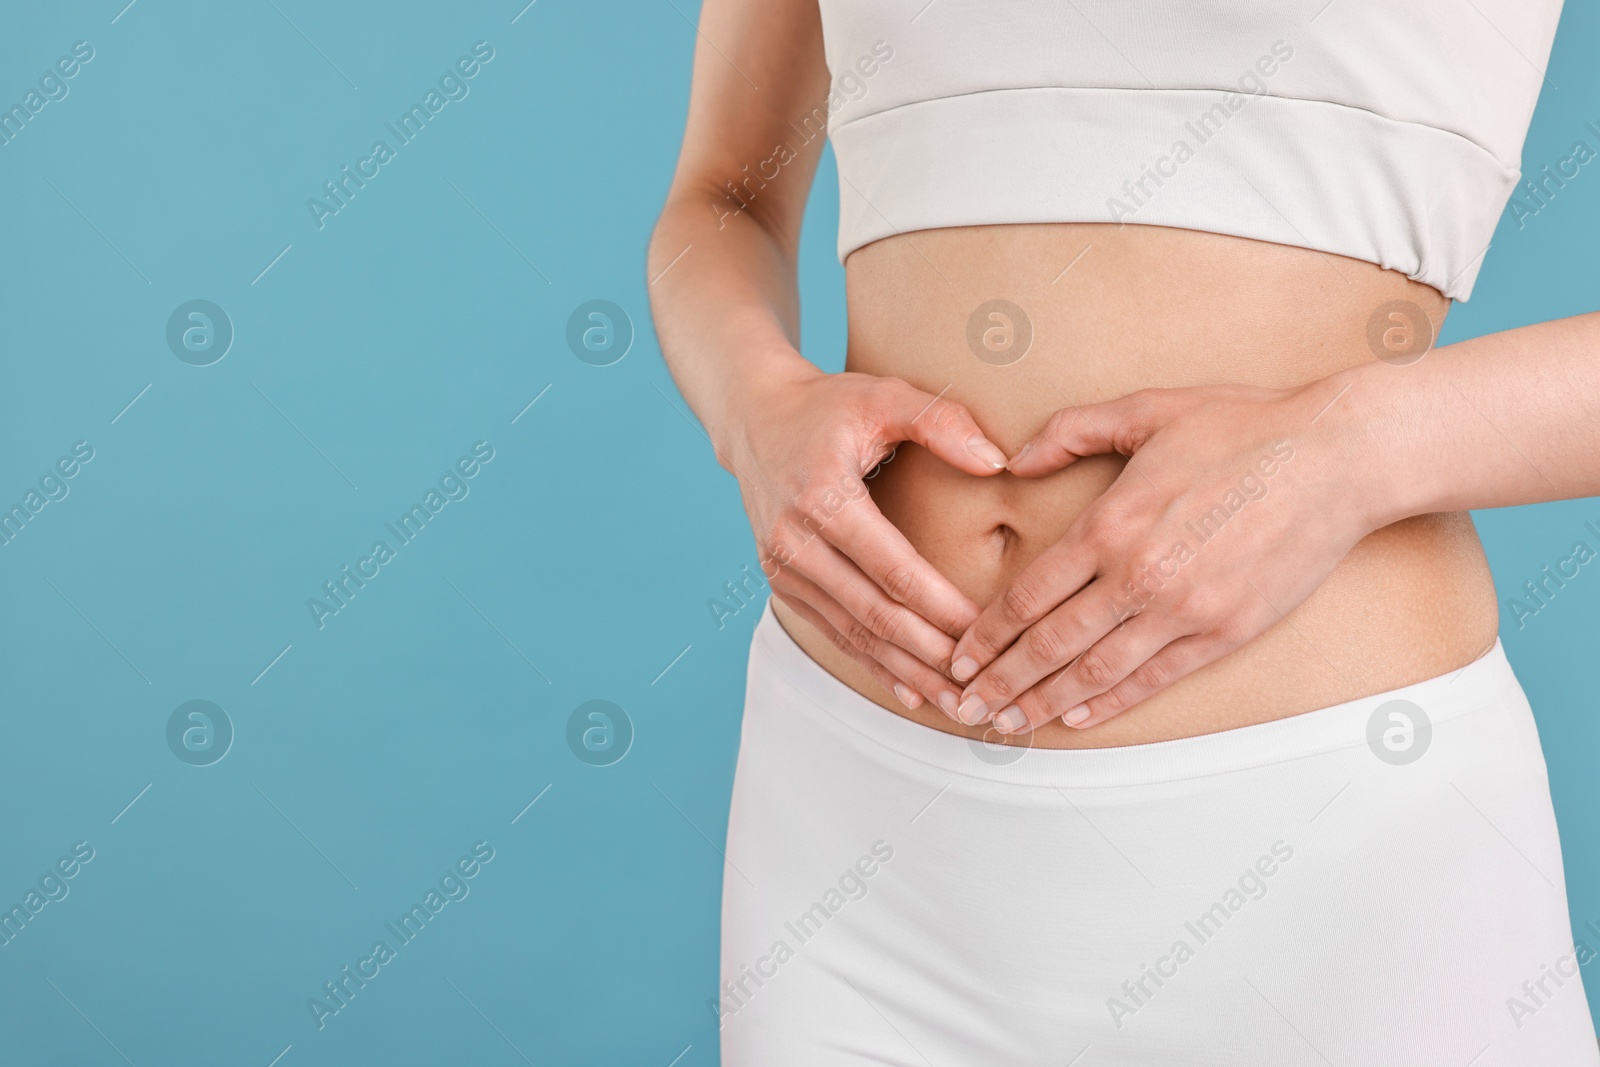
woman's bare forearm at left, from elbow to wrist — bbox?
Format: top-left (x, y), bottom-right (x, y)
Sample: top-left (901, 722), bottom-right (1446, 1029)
top-left (648, 190), bottom-right (816, 467)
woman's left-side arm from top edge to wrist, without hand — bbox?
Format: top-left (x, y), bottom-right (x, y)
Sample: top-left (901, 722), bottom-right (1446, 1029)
top-left (646, 0), bottom-right (827, 451)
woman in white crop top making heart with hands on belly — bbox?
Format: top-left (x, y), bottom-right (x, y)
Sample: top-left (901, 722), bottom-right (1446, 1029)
top-left (650, 0), bottom-right (1600, 1067)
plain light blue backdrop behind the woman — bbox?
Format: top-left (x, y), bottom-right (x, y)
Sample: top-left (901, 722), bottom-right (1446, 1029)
top-left (0, 0), bottom-right (1600, 1067)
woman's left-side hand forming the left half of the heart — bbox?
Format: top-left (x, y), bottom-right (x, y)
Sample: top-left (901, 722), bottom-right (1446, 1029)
top-left (729, 363), bottom-right (1005, 717)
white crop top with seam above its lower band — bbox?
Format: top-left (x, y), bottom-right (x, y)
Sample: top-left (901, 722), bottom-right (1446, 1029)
top-left (819, 0), bottom-right (1562, 301)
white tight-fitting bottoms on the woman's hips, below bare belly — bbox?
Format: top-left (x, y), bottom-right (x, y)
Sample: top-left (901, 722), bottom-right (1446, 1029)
top-left (715, 606), bottom-right (1600, 1067)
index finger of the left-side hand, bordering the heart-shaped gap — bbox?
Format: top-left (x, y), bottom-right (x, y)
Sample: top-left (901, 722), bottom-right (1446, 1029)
top-left (822, 488), bottom-right (978, 648)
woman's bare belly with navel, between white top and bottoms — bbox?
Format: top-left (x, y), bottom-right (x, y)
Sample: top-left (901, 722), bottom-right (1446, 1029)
top-left (774, 224), bottom-right (1498, 749)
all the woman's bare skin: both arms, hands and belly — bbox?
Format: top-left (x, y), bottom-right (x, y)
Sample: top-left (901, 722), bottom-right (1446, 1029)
top-left (650, 0), bottom-right (1600, 747)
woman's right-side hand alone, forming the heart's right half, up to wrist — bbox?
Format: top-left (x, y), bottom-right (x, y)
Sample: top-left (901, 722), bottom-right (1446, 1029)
top-left (952, 379), bottom-right (1381, 733)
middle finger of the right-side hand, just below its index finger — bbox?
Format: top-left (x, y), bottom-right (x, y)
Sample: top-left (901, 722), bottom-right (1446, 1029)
top-left (957, 582), bottom-right (1126, 725)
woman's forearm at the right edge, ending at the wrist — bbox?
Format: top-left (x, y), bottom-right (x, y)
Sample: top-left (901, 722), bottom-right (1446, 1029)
top-left (1314, 314), bottom-right (1600, 530)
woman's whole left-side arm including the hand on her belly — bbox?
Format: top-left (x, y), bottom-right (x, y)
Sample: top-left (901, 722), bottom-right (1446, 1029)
top-left (648, 0), bottom-right (1005, 709)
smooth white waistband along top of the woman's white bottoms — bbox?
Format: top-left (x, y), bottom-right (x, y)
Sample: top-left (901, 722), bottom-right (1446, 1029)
top-left (750, 601), bottom-right (1526, 787)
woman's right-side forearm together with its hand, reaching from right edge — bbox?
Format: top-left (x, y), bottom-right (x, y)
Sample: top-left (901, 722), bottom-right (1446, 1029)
top-left (954, 314), bottom-right (1600, 733)
